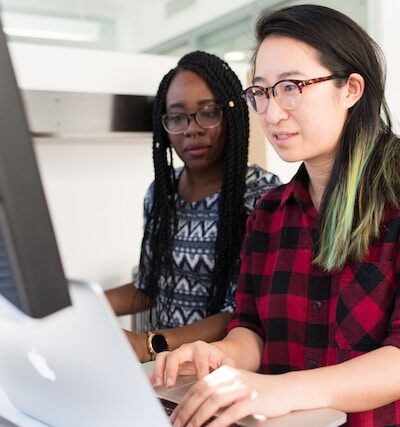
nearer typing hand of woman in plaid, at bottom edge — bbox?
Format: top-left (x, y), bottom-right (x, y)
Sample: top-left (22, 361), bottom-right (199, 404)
top-left (170, 366), bottom-right (293, 427)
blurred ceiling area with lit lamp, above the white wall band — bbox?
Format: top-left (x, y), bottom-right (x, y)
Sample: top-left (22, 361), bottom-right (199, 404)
top-left (2, 0), bottom-right (368, 61)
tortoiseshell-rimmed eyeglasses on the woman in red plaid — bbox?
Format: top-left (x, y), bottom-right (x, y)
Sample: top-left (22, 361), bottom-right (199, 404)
top-left (241, 75), bottom-right (339, 114)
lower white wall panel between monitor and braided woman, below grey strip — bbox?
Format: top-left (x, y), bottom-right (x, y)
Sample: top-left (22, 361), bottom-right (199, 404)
top-left (35, 137), bottom-right (153, 288)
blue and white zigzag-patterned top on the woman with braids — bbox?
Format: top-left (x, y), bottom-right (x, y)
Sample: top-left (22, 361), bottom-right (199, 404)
top-left (133, 165), bottom-right (280, 329)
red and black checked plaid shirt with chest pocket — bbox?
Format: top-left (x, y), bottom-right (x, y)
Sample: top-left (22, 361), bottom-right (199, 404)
top-left (229, 165), bottom-right (400, 427)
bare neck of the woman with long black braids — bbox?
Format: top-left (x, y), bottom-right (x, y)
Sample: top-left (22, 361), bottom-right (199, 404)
top-left (178, 165), bottom-right (223, 202)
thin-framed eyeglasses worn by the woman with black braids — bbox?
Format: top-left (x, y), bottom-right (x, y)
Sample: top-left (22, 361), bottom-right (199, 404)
top-left (162, 105), bottom-right (223, 135)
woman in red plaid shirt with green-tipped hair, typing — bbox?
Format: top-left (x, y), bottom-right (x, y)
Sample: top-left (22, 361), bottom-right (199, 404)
top-left (152, 5), bottom-right (400, 427)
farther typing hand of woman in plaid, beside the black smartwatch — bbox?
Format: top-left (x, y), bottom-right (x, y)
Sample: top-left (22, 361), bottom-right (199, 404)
top-left (150, 341), bottom-right (235, 387)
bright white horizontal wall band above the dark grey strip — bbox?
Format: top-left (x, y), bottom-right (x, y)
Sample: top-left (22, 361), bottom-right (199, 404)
top-left (9, 43), bottom-right (177, 95)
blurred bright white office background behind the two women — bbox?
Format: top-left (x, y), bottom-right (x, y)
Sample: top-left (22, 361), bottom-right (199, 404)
top-left (0, 0), bottom-right (400, 328)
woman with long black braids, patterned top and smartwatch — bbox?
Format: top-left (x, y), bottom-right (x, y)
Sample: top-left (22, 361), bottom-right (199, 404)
top-left (107, 52), bottom-right (279, 361)
